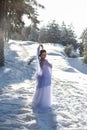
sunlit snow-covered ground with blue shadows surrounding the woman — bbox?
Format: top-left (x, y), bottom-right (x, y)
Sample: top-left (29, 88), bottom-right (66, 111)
top-left (0, 40), bottom-right (87, 130)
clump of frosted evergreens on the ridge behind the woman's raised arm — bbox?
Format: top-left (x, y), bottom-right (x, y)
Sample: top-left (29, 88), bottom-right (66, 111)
top-left (38, 20), bottom-right (77, 49)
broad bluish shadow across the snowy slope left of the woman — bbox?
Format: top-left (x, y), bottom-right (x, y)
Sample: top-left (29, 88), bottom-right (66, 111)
top-left (0, 42), bottom-right (35, 87)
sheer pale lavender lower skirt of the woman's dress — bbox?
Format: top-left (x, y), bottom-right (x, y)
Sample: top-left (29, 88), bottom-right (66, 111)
top-left (32, 86), bottom-right (52, 108)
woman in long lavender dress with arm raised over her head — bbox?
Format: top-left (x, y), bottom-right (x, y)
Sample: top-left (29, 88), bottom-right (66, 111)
top-left (32, 45), bottom-right (52, 108)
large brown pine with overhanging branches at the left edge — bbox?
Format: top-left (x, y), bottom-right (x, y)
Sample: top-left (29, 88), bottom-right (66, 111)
top-left (0, 0), bottom-right (44, 66)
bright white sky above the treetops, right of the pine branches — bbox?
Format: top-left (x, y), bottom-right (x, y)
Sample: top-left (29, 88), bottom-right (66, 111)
top-left (38, 0), bottom-right (87, 37)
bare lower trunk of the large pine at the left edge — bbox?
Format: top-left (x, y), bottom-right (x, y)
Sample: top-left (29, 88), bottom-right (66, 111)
top-left (0, 29), bottom-right (4, 67)
